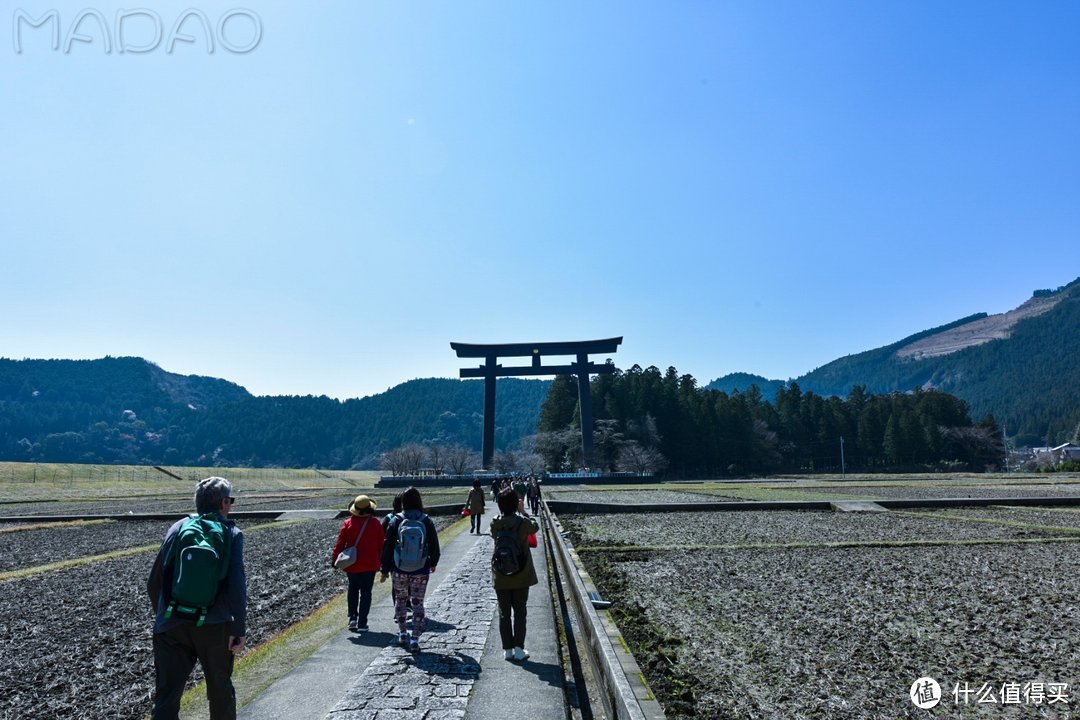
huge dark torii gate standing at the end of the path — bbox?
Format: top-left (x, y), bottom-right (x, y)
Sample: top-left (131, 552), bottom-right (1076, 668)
top-left (450, 337), bottom-right (622, 470)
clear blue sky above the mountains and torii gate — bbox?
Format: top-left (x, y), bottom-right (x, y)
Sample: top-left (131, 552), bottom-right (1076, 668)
top-left (0, 0), bottom-right (1080, 398)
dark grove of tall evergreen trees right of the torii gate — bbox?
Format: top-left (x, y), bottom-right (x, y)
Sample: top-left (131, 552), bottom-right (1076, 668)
top-left (536, 365), bottom-right (1003, 477)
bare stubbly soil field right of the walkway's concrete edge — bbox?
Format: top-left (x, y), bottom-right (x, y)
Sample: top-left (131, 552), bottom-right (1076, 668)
top-left (561, 513), bottom-right (1080, 720)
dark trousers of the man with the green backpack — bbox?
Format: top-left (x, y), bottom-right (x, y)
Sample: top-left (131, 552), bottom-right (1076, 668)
top-left (150, 623), bottom-right (237, 720)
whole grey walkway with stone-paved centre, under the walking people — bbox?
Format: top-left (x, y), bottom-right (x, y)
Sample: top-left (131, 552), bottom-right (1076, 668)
top-left (239, 522), bottom-right (566, 720)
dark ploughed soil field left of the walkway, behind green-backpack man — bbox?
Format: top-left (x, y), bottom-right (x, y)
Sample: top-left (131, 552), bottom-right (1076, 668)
top-left (0, 518), bottom-right (454, 720)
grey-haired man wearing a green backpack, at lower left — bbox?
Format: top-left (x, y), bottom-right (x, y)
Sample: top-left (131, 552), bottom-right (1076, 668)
top-left (147, 477), bottom-right (247, 720)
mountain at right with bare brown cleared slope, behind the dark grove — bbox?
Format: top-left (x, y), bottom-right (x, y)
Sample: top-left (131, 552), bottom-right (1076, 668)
top-left (707, 279), bottom-right (1080, 446)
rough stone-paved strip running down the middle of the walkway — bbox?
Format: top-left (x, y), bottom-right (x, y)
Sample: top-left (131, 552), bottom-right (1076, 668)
top-left (326, 536), bottom-right (496, 720)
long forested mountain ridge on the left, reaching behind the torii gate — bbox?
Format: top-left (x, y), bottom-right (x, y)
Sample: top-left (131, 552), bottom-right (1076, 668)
top-left (0, 357), bottom-right (551, 468)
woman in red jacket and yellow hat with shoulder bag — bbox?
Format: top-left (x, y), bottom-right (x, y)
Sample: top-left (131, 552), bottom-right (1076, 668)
top-left (330, 495), bottom-right (382, 633)
